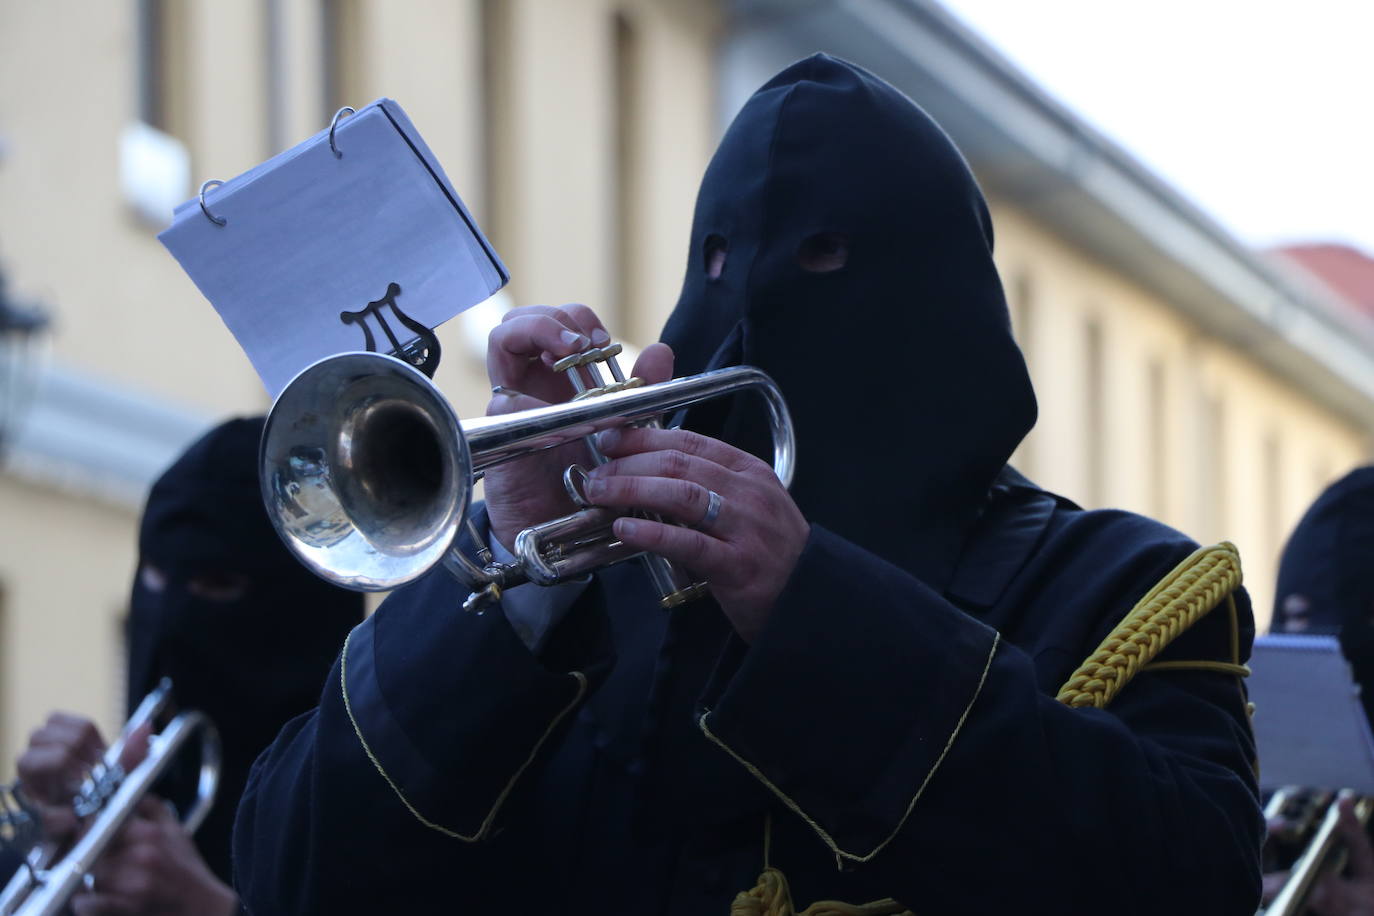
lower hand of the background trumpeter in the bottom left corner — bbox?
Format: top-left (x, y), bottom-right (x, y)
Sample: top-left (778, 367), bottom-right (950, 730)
top-left (71, 798), bottom-right (238, 916)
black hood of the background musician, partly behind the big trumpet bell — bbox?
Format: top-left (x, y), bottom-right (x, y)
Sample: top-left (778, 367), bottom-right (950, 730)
top-left (126, 417), bottom-right (363, 882)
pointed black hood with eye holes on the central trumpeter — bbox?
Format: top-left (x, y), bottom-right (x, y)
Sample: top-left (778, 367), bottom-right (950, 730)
top-left (662, 55), bottom-right (1036, 589)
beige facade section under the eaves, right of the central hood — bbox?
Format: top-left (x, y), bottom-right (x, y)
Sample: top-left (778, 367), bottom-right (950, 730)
top-left (993, 206), bottom-right (1369, 612)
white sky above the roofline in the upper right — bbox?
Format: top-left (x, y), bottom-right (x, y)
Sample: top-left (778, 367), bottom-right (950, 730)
top-left (943, 0), bottom-right (1374, 255)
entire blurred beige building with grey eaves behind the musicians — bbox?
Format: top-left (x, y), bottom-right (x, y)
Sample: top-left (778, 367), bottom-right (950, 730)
top-left (0, 0), bottom-right (1374, 779)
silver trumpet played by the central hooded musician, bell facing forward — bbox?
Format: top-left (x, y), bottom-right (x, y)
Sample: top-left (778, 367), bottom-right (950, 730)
top-left (260, 345), bottom-right (796, 610)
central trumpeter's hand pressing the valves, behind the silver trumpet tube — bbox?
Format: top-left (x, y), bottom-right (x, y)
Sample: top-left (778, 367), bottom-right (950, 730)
top-left (484, 305), bottom-right (673, 549)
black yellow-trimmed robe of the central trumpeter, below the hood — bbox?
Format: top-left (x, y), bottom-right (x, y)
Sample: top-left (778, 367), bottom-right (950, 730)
top-left (236, 483), bottom-right (1263, 915)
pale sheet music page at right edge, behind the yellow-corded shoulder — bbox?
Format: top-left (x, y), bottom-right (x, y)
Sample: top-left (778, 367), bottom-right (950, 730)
top-left (1246, 634), bottom-right (1374, 795)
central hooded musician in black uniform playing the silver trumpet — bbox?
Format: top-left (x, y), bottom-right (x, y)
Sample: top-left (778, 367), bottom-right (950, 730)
top-left (235, 55), bottom-right (1263, 915)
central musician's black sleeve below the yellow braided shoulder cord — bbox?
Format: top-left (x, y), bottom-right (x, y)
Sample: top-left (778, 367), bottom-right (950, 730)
top-left (699, 527), bottom-right (1263, 913)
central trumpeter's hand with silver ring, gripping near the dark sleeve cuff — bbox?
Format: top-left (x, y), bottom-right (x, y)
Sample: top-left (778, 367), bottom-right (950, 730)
top-left (587, 428), bottom-right (811, 641)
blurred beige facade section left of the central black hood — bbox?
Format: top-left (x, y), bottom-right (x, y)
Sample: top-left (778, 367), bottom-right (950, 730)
top-left (0, 0), bottom-right (721, 763)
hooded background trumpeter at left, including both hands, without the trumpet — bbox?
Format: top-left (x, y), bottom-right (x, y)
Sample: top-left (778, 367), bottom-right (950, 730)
top-left (10, 417), bottom-right (363, 916)
